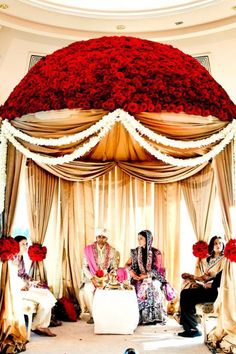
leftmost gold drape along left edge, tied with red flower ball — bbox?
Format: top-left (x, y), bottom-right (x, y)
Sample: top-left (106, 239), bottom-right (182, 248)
top-left (0, 145), bottom-right (27, 353)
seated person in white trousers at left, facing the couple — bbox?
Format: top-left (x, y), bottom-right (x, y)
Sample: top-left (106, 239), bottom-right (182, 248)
top-left (13, 236), bottom-right (57, 337)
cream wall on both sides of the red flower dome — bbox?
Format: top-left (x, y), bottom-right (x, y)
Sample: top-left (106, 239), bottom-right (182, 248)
top-left (0, 27), bottom-right (236, 104)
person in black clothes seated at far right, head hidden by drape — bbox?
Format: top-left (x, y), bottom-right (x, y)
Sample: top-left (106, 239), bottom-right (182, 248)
top-left (178, 270), bottom-right (222, 338)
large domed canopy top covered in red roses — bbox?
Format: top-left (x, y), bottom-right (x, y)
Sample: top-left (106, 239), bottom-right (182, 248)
top-left (0, 37), bottom-right (236, 120)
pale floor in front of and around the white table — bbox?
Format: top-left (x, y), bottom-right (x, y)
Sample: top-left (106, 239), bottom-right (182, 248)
top-left (26, 318), bottom-right (210, 354)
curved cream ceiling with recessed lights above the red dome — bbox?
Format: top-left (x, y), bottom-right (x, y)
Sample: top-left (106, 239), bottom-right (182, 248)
top-left (0, 0), bottom-right (236, 39)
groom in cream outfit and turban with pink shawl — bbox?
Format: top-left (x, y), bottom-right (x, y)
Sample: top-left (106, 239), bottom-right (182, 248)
top-left (83, 228), bottom-right (119, 323)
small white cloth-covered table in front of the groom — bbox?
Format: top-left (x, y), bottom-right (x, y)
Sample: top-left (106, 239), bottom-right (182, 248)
top-left (93, 289), bottom-right (139, 334)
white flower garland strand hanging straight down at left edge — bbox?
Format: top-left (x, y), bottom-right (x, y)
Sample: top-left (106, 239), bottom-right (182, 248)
top-left (0, 130), bottom-right (7, 214)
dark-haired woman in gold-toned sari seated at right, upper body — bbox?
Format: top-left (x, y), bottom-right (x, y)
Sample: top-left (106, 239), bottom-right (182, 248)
top-left (182, 236), bottom-right (225, 289)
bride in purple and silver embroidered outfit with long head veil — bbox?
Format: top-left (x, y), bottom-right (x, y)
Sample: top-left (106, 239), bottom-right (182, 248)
top-left (126, 230), bottom-right (167, 325)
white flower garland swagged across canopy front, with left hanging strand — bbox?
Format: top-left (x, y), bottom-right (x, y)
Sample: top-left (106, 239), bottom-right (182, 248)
top-left (0, 109), bottom-right (236, 213)
